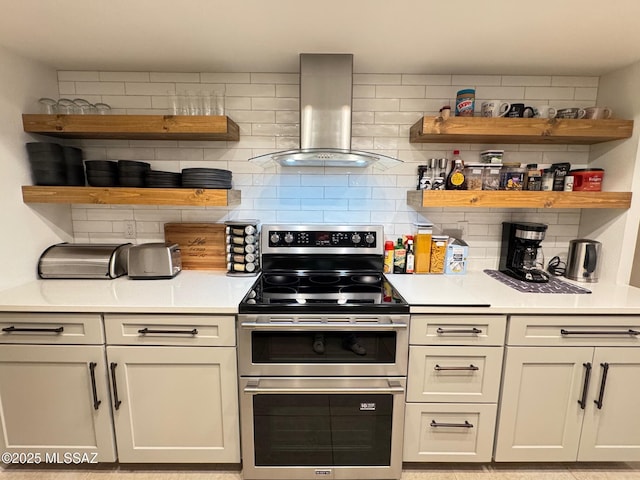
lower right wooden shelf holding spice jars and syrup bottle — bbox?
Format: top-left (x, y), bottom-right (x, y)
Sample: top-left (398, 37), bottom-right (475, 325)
top-left (407, 190), bottom-right (631, 209)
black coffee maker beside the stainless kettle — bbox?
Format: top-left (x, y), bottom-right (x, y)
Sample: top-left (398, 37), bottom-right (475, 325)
top-left (498, 222), bottom-right (549, 283)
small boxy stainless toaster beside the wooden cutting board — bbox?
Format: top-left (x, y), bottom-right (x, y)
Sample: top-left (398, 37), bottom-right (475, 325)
top-left (128, 243), bottom-right (182, 280)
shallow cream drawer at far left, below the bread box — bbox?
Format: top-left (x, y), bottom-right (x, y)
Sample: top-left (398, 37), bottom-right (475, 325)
top-left (0, 312), bottom-right (104, 345)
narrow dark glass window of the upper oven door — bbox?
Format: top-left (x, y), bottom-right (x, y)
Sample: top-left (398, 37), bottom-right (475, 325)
top-left (251, 330), bottom-right (396, 364)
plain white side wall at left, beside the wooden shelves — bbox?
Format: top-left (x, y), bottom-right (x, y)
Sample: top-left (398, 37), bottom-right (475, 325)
top-left (0, 48), bottom-right (71, 288)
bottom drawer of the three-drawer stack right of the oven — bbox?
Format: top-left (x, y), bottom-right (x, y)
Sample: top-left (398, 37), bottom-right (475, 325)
top-left (403, 403), bottom-right (497, 462)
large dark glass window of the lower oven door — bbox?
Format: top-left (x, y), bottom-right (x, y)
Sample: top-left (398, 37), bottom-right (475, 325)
top-left (253, 394), bottom-right (393, 466)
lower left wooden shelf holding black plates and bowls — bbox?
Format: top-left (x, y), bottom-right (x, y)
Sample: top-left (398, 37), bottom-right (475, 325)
top-left (22, 185), bottom-right (240, 207)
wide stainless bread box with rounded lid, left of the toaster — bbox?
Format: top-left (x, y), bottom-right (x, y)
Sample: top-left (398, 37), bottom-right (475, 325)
top-left (38, 243), bottom-right (131, 279)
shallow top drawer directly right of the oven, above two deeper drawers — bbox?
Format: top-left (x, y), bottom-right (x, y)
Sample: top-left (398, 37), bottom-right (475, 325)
top-left (409, 315), bottom-right (507, 346)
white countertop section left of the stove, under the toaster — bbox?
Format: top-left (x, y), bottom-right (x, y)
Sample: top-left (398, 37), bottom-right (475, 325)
top-left (0, 270), bottom-right (256, 314)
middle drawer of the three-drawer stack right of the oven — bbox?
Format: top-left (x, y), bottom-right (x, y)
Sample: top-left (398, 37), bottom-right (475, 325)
top-left (407, 346), bottom-right (503, 403)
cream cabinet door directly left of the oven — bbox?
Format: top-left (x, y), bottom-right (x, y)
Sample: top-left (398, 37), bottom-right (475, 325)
top-left (107, 346), bottom-right (240, 463)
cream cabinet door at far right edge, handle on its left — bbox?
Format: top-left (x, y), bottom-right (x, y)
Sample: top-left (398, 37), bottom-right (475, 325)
top-left (578, 348), bottom-right (640, 462)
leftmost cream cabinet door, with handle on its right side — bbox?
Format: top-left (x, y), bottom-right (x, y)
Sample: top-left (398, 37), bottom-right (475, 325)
top-left (0, 345), bottom-right (116, 463)
